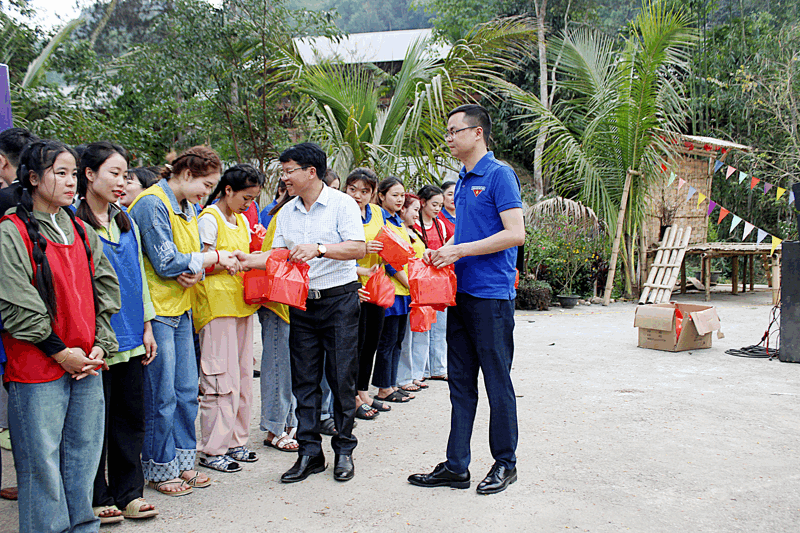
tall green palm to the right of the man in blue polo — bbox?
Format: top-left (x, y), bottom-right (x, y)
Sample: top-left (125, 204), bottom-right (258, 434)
top-left (509, 0), bottom-right (695, 304)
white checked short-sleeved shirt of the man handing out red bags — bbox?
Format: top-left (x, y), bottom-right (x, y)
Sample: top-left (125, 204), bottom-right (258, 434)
top-left (272, 187), bottom-right (366, 290)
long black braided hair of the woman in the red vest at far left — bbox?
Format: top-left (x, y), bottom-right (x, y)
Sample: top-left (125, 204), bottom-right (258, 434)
top-left (16, 140), bottom-right (99, 321)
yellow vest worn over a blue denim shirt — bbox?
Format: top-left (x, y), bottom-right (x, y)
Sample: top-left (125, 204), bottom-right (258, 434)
top-left (128, 184), bottom-right (202, 316)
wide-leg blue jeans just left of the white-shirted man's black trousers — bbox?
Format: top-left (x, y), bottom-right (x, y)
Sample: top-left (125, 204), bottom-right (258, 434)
top-left (258, 307), bottom-right (297, 436)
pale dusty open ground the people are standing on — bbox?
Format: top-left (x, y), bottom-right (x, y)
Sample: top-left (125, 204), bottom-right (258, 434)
top-left (0, 292), bottom-right (800, 533)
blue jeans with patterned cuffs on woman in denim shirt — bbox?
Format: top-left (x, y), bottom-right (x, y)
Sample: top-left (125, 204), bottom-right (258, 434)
top-left (142, 311), bottom-right (198, 481)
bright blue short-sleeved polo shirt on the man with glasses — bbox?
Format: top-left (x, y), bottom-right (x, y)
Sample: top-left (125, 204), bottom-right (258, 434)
top-left (454, 152), bottom-right (522, 300)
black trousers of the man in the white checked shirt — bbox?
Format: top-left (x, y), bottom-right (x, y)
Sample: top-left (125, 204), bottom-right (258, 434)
top-left (289, 291), bottom-right (360, 455)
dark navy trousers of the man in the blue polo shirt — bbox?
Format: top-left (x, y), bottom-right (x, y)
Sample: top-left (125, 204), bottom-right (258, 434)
top-left (447, 293), bottom-right (518, 473)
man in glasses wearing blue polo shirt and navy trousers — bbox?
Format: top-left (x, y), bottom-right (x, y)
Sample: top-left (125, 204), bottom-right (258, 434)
top-left (408, 105), bottom-right (525, 494)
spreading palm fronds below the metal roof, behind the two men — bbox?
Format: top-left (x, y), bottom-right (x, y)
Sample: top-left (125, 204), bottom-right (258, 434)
top-left (271, 17), bottom-right (534, 181)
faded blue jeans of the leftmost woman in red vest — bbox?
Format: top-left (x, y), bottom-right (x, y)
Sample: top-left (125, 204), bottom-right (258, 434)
top-left (8, 374), bottom-right (105, 533)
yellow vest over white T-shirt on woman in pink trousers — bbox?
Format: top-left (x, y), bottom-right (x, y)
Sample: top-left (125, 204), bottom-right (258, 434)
top-left (193, 206), bottom-right (258, 332)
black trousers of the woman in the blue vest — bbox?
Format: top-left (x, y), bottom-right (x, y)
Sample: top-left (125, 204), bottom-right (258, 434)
top-left (92, 356), bottom-right (144, 510)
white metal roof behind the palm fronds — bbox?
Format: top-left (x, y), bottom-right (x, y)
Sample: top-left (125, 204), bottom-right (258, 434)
top-left (295, 28), bottom-right (450, 64)
